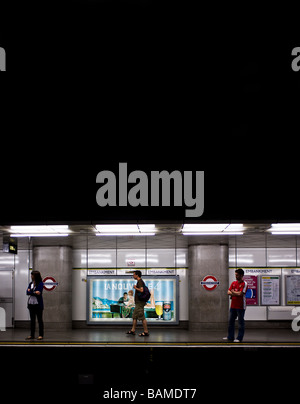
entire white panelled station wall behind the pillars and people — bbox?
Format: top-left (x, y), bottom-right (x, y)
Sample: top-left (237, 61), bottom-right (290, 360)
top-left (0, 243), bottom-right (300, 323)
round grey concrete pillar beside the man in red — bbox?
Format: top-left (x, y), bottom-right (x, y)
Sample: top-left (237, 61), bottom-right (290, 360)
top-left (188, 244), bottom-right (229, 330)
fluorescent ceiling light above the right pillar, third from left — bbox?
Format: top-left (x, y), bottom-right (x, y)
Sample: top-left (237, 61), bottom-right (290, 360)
top-left (182, 223), bottom-right (245, 236)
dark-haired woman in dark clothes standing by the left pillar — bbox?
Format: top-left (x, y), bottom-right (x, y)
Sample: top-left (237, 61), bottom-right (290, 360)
top-left (26, 271), bottom-right (44, 341)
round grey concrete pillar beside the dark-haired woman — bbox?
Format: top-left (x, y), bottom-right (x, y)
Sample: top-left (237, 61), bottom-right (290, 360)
top-left (33, 246), bottom-right (72, 332)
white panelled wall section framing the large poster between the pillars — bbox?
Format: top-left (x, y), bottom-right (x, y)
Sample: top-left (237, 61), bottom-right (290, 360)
top-left (72, 248), bottom-right (188, 321)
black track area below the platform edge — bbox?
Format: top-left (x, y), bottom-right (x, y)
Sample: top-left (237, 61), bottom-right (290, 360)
top-left (0, 346), bottom-right (298, 402)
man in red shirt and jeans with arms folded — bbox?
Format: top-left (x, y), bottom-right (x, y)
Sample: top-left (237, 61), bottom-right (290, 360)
top-left (224, 268), bottom-right (247, 342)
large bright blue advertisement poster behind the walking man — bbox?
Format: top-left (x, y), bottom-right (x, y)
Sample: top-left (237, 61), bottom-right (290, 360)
top-left (87, 276), bottom-right (179, 324)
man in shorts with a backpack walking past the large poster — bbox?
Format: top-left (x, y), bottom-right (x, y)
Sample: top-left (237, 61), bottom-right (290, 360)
top-left (127, 270), bottom-right (149, 337)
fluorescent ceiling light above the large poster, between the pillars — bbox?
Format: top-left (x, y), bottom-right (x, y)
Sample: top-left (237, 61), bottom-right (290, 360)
top-left (96, 224), bottom-right (155, 236)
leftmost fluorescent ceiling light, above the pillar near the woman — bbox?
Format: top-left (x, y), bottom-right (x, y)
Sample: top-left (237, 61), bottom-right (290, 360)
top-left (10, 225), bottom-right (69, 237)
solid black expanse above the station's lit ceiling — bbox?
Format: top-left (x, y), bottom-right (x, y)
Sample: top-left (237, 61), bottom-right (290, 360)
top-left (0, 0), bottom-right (299, 224)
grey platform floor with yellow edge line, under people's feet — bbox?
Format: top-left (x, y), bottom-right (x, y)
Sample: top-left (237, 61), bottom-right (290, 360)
top-left (0, 328), bottom-right (300, 347)
